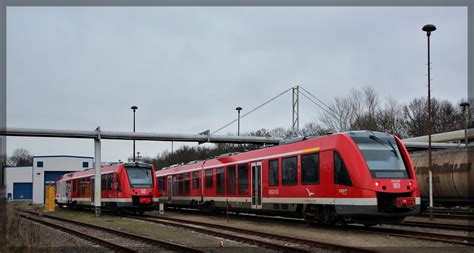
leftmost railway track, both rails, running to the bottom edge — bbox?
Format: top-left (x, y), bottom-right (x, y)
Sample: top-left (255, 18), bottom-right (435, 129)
top-left (20, 210), bottom-right (204, 253)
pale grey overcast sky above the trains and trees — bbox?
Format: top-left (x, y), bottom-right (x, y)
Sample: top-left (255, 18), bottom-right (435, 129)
top-left (7, 7), bottom-right (467, 161)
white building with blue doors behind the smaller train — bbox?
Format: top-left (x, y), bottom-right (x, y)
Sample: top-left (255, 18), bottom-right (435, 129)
top-left (5, 155), bottom-right (94, 204)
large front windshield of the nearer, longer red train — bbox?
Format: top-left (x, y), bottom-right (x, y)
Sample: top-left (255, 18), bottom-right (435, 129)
top-left (352, 135), bottom-right (408, 178)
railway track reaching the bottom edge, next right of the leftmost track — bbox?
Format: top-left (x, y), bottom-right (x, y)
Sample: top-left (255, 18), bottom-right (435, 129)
top-left (125, 215), bottom-right (373, 252)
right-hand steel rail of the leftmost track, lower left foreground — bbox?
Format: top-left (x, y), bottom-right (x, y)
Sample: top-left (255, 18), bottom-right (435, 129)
top-left (21, 210), bottom-right (204, 253)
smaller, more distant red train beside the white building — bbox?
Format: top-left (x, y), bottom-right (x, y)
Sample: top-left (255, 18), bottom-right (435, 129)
top-left (55, 163), bottom-right (158, 213)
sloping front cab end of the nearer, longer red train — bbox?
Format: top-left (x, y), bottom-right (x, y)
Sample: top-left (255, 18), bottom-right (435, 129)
top-left (335, 131), bottom-right (420, 224)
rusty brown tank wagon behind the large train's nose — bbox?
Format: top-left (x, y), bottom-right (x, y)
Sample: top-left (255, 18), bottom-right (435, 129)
top-left (410, 148), bottom-right (474, 206)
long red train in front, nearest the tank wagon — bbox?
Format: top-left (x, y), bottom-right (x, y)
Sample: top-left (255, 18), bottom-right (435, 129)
top-left (156, 131), bottom-right (420, 225)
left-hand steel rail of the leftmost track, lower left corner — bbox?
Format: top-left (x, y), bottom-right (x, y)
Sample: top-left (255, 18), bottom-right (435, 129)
top-left (20, 214), bottom-right (137, 252)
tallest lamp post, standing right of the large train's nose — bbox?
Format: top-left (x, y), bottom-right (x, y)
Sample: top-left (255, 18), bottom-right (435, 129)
top-left (421, 24), bottom-right (436, 220)
